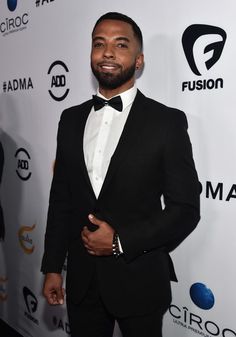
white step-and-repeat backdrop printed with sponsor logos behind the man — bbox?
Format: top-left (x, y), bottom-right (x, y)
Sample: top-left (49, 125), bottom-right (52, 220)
top-left (0, 0), bottom-right (236, 337)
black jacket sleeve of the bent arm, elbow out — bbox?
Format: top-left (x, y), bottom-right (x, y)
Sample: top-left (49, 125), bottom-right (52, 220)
top-left (118, 110), bottom-right (200, 262)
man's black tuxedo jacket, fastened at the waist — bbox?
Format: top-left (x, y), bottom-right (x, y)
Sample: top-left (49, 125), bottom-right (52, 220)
top-left (42, 91), bottom-right (199, 316)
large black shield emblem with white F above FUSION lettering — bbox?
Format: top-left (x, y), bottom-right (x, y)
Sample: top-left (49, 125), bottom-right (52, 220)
top-left (182, 24), bottom-right (226, 76)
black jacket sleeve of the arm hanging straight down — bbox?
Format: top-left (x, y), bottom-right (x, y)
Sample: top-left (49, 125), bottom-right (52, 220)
top-left (41, 112), bottom-right (71, 273)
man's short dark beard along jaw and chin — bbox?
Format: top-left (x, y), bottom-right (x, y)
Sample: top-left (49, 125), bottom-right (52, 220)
top-left (91, 63), bottom-right (136, 89)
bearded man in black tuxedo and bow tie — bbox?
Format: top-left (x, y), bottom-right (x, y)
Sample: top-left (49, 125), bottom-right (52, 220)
top-left (42, 13), bottom-right (199, 337)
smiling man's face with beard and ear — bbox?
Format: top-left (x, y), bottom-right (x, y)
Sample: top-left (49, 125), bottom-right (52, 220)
top-left (91, 20), bottom-right (143, 93)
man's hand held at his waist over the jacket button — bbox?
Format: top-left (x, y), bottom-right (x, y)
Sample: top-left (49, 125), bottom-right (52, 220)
top-left (81, 214), bottom-right (115, 256)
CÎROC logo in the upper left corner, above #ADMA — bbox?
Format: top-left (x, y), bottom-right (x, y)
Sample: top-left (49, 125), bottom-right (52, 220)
top-left (0, 0), bottom-right (29, 36)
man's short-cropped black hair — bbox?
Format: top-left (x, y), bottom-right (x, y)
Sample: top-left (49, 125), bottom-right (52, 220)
top-left (92, 12), bottom-right (143, 50)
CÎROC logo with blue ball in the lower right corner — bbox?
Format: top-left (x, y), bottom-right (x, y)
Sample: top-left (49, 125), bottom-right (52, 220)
top-left (169, 282), bottom-right (236, 337)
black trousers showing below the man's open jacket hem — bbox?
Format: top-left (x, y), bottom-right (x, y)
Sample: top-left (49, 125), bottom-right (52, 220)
top-left (67, 272), bottom-right (163, 337)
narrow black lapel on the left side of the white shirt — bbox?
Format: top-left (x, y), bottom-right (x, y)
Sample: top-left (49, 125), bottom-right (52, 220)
top-left (75, 101), bottom-right (96, 198)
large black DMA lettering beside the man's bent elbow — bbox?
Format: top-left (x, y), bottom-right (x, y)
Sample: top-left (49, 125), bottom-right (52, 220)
top-left (199, 181), bottom-right (236, 201)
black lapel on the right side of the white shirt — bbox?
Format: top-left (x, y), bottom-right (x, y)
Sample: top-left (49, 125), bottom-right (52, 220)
top-left (98, 90), bottom-right (146, 199)
